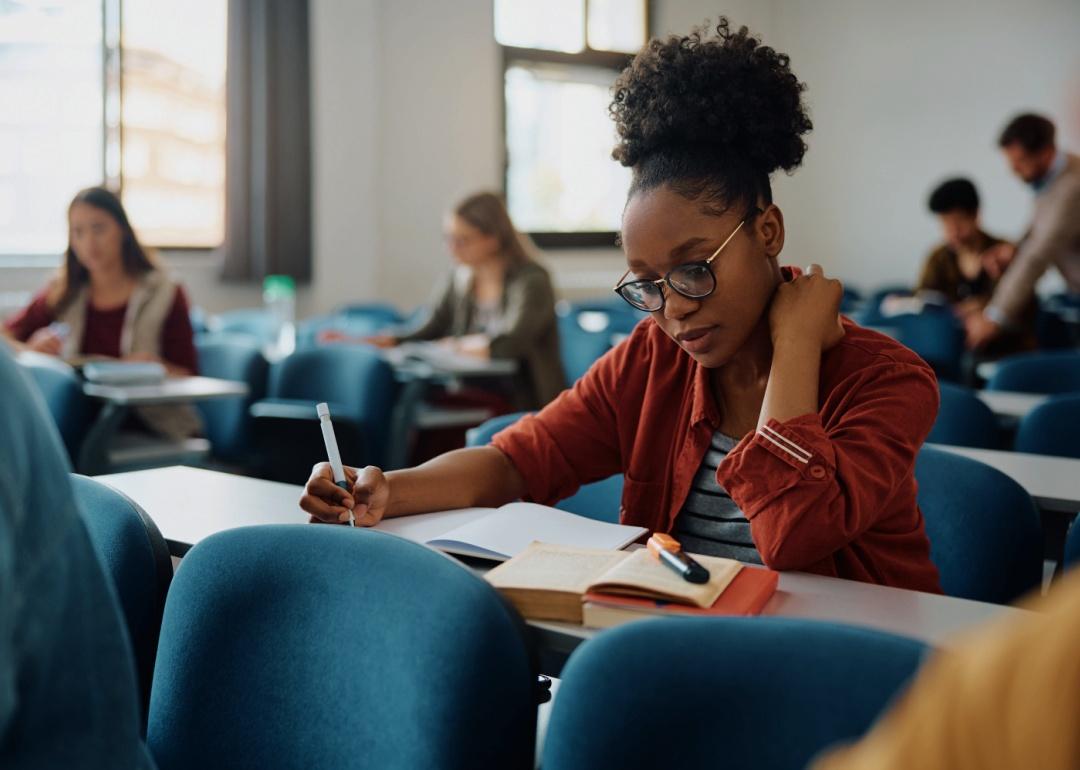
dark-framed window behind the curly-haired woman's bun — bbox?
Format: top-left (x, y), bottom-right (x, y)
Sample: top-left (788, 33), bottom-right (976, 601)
top-left (495, 0), bottom-right (648, 247)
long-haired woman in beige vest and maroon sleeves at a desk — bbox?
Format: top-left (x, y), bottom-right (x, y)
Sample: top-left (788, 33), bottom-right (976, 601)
top-left (5, 187), bottom-right (199, 437)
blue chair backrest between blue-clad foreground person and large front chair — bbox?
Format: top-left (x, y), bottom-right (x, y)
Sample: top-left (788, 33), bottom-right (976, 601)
top-left (71, 474), bottom-right (173, 718)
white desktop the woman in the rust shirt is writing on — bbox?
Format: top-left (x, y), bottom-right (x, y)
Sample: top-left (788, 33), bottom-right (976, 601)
top-left (98, 467), bottom-right (1020, 654)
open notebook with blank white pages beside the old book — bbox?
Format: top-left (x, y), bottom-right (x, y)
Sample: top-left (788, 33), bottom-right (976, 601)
top-left (376, 502), bottom-right (647, 562)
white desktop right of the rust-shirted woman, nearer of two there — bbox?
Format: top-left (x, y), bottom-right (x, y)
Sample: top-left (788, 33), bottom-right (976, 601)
top-left (930, 444), bottom-right (1080, 513)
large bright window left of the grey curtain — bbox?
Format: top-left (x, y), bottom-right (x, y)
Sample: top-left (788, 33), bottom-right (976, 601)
top-left (0, 0), bottom-right (227, 255)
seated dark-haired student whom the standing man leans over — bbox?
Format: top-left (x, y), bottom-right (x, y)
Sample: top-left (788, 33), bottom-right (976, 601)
top-left (916, 178), bottom-right (1037, 355)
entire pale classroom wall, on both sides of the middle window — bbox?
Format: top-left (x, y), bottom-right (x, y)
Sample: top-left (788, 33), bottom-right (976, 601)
top-left (0, 0), bottom-right (1080, 313)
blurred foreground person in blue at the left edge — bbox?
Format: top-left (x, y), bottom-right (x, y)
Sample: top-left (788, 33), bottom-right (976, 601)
top-left (0, 342), bottom-right (153, 770)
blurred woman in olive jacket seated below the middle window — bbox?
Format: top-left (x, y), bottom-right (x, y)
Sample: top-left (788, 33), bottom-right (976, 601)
top-left (368, 192), bottom-right (566, 409)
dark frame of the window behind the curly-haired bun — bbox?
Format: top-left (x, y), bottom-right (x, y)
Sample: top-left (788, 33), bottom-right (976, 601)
top-left (491, 0), bottom-right (653, 249)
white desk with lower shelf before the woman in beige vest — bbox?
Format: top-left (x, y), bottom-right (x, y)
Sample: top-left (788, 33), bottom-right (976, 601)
top-left (76, 377), bottom-right (247, 475)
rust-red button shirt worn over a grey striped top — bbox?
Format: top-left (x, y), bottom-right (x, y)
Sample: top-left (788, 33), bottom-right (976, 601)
top-left (492, 308), bottom-right (941, 593)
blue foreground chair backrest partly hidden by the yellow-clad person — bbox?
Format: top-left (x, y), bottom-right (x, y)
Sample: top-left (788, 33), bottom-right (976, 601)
top-left (543, 618), bottom-right (926, 770)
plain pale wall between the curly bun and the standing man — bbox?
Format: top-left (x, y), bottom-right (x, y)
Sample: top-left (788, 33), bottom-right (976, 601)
top-left (769, 0), bottom-right (1080, 287)
